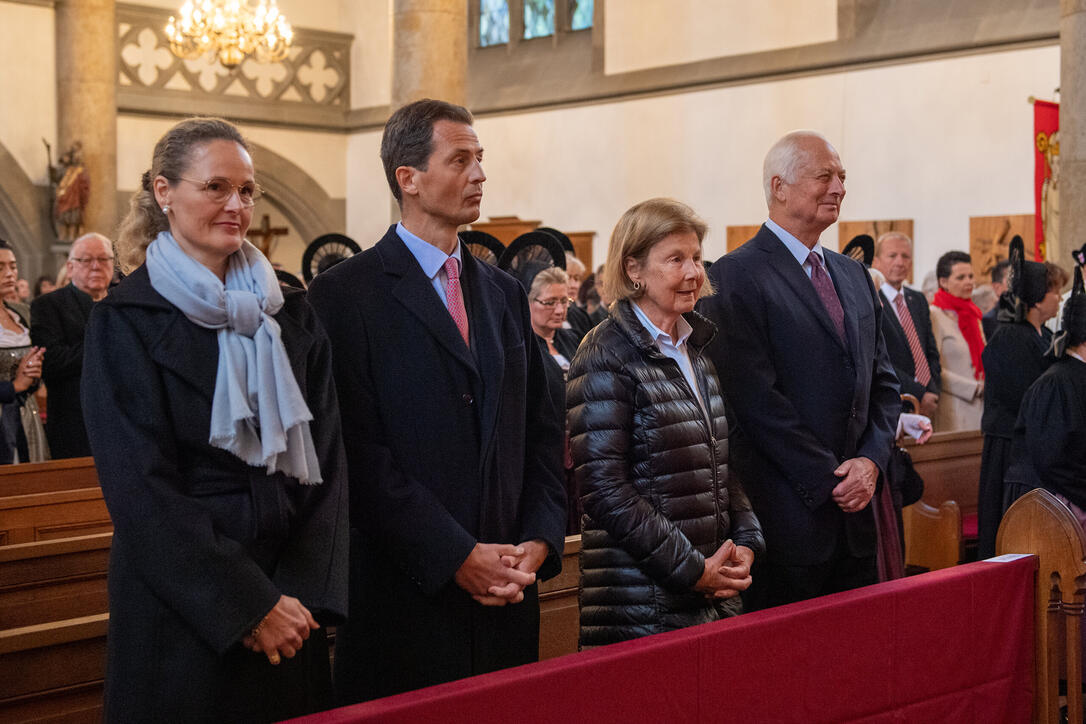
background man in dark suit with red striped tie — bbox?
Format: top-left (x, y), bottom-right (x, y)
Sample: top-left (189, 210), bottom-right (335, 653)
top-left (871, 231), bottom-right (942, 418)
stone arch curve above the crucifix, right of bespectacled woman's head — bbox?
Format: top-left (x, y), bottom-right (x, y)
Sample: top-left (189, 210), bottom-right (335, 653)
top-left (250, 142), bottom-right (346, 250)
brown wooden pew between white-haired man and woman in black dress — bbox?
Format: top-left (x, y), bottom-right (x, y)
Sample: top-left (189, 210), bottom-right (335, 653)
top-left (902, 430), bottom-right (984, 571)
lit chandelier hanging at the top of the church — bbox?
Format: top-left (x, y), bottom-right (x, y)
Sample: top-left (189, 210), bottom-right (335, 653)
top-left (166, 0), bottom-right (294, 68)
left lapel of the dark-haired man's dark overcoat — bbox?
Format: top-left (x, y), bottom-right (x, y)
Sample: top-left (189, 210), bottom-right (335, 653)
top-left (375, 227), bottom-right (478, 374)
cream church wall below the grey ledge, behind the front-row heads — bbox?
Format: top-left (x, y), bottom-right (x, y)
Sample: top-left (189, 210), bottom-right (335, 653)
top-left (348, 40), bottom-right (1059, 284)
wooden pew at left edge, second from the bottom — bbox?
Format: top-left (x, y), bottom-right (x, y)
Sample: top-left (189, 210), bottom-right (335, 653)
top-left (0, 533), bottom-right (113, 630)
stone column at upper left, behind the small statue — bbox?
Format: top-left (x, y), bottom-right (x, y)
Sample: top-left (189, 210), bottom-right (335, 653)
top-left (53, 0), bottom-right (117, 239)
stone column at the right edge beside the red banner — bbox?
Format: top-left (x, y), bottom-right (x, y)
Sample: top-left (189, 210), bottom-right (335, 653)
top-left (1059, 0), bottom-right (1086, 269)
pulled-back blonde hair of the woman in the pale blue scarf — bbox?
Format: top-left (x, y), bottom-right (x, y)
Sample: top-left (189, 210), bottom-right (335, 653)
top-left (115, 118), bottom-right (249, 274)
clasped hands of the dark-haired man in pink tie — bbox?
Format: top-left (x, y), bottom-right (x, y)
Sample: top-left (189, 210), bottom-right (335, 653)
top-left (454, 541), bottom-right (547, 606)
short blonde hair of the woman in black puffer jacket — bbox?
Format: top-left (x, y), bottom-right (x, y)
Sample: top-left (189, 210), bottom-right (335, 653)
top-left (603, 199), bottom-right (712, 302)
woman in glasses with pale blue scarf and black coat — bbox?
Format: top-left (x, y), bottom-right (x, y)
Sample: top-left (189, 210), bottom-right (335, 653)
top-left (83, 118), bottom-right (348, 722)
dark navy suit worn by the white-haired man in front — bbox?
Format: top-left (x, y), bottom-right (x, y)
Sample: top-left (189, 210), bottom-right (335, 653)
top-left (700, 226), bottom-right (901, 573)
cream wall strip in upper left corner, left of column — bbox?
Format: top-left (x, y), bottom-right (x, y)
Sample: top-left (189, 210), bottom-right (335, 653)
top-left (0, 2), bottom-right (62, 186)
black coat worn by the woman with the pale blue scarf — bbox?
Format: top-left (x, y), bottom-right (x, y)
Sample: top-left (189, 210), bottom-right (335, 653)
top-left (81, 267), bottom-right (348, 722)
